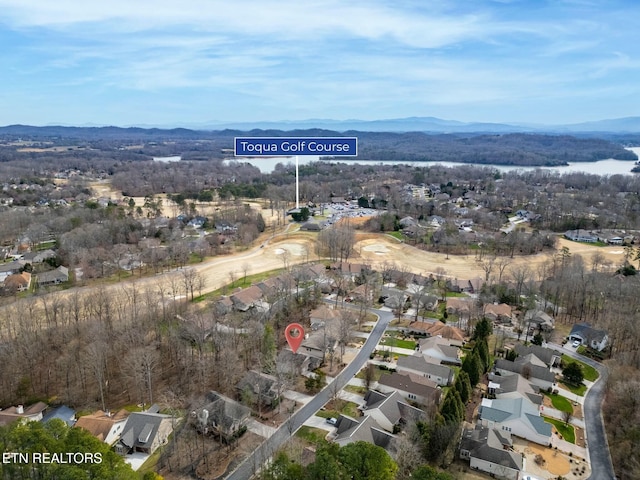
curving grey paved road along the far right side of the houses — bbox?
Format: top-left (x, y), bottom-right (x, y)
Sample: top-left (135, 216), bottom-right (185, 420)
top-left (548, 344), bottom-right (616, 480)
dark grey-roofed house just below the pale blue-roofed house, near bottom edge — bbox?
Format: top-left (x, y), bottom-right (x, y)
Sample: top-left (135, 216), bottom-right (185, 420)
top-left (460, 425), bottom-right (523, 480)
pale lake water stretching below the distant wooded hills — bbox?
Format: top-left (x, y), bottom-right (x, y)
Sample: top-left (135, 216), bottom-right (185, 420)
top-left (230, 147), bottom-right (640, 175)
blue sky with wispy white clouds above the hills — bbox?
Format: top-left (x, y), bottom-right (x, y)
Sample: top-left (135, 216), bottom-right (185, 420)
top-left (0, 0), bottom-right (640, 126)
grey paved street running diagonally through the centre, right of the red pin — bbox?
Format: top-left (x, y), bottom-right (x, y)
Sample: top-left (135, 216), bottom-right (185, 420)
top-left (225, 311), bottom-right (393, 480)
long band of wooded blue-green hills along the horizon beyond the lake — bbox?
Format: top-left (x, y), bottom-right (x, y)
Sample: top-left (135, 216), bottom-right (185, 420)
top-left (0, 122), bottom-right (637, 166)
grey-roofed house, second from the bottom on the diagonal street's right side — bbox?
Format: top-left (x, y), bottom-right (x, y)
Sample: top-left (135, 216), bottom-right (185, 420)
top-left (362, 390), bottom-right (425, 433)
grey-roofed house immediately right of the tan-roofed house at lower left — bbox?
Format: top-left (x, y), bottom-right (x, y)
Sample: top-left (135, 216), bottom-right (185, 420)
top-left (116, 409), bottom-right (175, 455)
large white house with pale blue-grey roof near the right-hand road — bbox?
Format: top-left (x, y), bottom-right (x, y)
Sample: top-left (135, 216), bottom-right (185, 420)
top-left (478, 395), bottom-right (552, 446)
